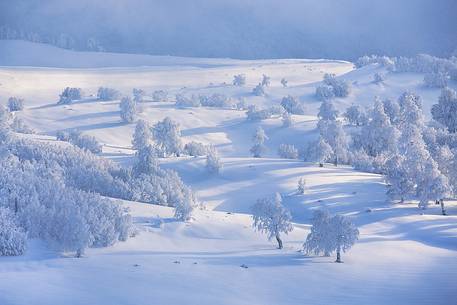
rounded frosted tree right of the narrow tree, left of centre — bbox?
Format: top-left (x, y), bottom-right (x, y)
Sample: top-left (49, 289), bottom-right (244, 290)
top-left (152, 117), bottom-right (183, 157)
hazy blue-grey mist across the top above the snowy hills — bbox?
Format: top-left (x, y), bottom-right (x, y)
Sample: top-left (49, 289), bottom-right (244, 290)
top-left (0, 0), bottom-right (457, 59)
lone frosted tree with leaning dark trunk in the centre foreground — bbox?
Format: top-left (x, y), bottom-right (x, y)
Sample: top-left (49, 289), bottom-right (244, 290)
top-left (251, 193), bottom-right (293, 249)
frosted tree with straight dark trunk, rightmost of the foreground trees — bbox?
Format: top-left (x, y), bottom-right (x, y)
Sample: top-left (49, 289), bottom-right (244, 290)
top-left (330, 215), bottom-right (359, 263)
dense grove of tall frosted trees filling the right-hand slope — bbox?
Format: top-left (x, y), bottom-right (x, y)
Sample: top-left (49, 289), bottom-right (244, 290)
top-left (306, 88), bottom-right (457, 215)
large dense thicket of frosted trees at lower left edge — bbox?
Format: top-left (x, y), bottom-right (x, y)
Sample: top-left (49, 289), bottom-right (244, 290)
top-left (0, 129), bottom-right (132, 256)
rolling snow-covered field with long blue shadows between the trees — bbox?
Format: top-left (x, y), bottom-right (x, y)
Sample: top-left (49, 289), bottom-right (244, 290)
top-left (0, 41), bottom-right (457, 305)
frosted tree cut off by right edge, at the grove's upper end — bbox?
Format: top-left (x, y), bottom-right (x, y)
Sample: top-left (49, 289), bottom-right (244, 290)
top-left (432, 88), bottom-right (457, 133)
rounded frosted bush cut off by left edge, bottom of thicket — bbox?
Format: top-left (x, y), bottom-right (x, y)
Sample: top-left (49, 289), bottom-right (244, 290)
top-left (0, 206), bottom-right (26, 256)
